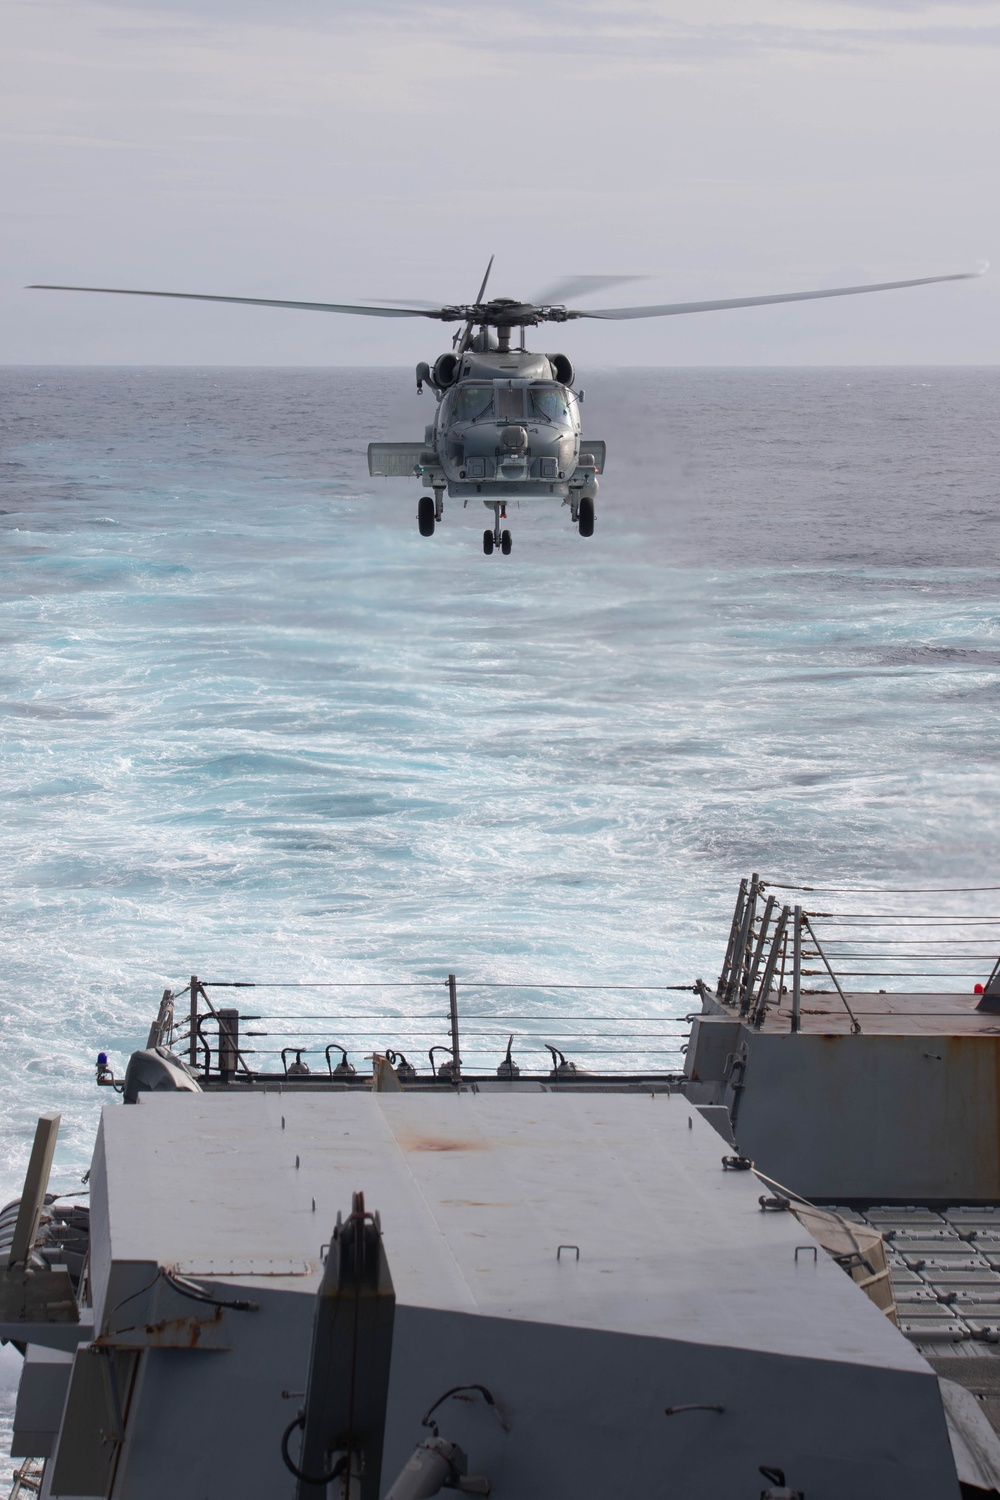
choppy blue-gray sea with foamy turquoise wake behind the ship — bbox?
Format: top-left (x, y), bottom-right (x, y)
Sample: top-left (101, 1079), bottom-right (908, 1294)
top-left (0, 369), bottom-right (1000, 1475)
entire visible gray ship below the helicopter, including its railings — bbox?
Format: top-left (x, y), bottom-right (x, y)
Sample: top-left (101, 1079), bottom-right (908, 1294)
top-left (0, 878), bottom-right (1000, 1500)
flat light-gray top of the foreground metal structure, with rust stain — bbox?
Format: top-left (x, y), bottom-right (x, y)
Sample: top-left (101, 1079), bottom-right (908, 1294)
top-left (93, 1091), bottom-right (921, 1374)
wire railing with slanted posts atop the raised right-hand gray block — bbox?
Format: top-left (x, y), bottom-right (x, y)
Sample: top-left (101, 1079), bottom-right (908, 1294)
top-left (715, 872), bottom-right (1000, 1032)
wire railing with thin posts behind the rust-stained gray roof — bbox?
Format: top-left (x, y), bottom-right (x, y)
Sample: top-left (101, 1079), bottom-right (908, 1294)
top-left (160, 974), bottom-right (694, 1082)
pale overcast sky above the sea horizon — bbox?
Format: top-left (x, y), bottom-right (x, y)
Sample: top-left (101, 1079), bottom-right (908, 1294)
top-left (0, 0), bottom-right (1000, 366)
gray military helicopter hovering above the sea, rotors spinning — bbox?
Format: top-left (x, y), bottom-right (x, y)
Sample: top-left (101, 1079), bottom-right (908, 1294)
top-left (28, 257), bottom-right (987, 557)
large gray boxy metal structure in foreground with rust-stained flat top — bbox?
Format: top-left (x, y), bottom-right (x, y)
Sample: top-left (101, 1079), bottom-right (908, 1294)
top-left (4, 1089), bottom-right (957, 1500)
